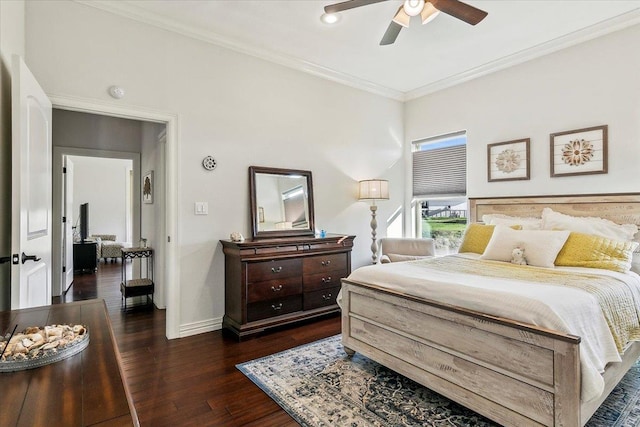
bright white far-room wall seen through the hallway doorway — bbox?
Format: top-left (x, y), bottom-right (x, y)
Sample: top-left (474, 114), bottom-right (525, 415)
top-left (69, 156), bottom-right (133, 243)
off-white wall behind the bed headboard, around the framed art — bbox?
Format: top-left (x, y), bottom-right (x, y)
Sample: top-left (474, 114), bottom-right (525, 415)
top-left (405, 25), bottom-right (640, 207)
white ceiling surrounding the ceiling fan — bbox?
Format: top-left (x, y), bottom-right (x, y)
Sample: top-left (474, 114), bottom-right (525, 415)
top-left (78, 0), bottom-right (640, 100)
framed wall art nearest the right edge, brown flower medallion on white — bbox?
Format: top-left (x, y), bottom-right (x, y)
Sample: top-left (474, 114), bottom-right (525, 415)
top-left (551, 125), bottom-right (608, 177)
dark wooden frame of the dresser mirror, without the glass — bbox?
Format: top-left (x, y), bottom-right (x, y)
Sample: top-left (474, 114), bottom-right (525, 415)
top-left (249, 166), bottom-right (315, 239)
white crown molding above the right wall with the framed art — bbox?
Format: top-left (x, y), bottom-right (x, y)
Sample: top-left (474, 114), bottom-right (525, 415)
top-left (404, 8), bottom-right (640, 101)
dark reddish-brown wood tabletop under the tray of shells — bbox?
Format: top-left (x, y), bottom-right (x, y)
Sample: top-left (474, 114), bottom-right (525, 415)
top-left (0, 300), bottom-right (139, 426)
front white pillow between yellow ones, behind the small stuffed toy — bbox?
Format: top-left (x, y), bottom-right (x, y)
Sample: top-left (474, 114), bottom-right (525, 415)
top-left (480, 225), bottom-right (570, 267)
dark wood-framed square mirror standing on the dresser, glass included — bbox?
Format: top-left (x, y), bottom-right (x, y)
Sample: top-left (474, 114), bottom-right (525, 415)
top-left (249, 166), bottom-right (315, 238)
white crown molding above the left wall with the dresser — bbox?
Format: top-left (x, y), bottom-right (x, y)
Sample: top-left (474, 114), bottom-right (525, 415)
top-left (73, 0), bottom-right (405, 101)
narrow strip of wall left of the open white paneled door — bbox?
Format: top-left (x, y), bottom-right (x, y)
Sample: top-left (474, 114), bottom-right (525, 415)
top-left (0, 0), bottom-right (25, 310)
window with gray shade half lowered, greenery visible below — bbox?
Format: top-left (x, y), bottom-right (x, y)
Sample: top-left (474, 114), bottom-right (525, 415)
top-left (413, 131), bottom-right (468, 255)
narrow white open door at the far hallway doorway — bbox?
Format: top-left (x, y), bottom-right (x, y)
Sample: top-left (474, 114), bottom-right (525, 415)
top-left (62, 156), bottom-right (75, 292)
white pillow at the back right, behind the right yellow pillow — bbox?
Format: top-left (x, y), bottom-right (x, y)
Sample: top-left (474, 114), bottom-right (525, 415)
top-left (542, 208), bottom-right (638, 242)
